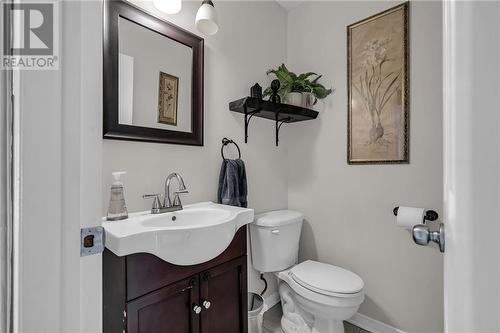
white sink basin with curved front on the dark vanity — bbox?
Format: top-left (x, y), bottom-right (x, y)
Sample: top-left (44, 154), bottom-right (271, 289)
top-left (103, 202), bottom-right (254, 266)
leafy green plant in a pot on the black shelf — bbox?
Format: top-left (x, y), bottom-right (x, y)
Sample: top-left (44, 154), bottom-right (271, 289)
top-left (263, 64), bottom-right (333, 107)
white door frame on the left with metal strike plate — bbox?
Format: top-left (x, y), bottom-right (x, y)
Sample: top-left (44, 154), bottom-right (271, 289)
top-left (16, 0), bottom-right (102, 332)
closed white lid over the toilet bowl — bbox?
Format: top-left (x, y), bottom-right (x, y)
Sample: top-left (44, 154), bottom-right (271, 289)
top-left (291, 260), bottom-right (364, 294)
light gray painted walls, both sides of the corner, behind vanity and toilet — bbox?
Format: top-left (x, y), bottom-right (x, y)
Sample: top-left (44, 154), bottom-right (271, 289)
top-left (103, 1), bottom-right (443, 332)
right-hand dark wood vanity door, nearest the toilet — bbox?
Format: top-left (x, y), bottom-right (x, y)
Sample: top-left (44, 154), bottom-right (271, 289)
top-left (200, 256), bottom-right (248, 333)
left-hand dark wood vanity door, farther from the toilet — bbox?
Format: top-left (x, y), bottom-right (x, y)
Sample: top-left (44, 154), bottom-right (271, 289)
top-left (127, 276), bottom-right (201, 333)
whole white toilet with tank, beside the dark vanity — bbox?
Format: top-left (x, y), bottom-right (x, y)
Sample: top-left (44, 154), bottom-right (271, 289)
top-left (250, 210), bottom-right (364, 333)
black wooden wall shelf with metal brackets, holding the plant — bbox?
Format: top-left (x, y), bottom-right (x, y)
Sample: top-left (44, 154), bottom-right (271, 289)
top-left (229, 97), bottom-right (318, 146)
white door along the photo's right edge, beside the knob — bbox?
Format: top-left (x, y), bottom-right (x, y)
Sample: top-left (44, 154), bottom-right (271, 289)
top-left (446, 1), bottom-right (500, 333)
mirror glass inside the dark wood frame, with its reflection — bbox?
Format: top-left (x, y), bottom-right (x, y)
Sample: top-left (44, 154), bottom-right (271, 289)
top-left (118, 17), bottom-right (193, 132)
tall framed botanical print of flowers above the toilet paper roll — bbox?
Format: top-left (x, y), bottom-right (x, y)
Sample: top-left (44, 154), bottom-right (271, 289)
top-left (347, 2), bottom-right (410, 164)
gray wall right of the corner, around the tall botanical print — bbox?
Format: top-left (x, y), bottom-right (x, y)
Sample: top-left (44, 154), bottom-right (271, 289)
top-left (285, 1), bottom-right (443, 332)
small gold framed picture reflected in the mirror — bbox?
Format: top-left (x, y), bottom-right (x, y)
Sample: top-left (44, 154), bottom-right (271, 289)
top-left (158, 71), bottom-right (179, 126)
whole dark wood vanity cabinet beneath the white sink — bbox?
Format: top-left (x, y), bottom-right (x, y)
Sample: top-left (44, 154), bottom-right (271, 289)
top-left (103, 227), bottom-right (247, 333)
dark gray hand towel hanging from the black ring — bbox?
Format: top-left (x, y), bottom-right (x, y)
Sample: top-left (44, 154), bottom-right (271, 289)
top-left (217, 159), bottom-right (248, 207)
